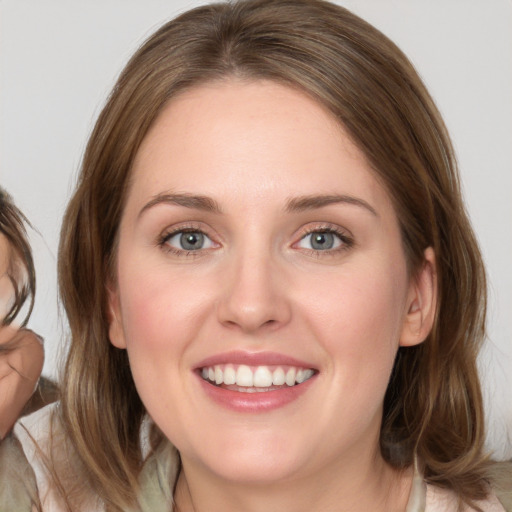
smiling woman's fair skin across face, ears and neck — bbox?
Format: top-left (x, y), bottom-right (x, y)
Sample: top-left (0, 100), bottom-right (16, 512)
top-left (109, 80), bottom-right (435, 512)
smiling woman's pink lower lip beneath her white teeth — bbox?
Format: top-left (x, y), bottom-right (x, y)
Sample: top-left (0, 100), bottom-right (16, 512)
top-left (197, 374), bottom-right (317, 412)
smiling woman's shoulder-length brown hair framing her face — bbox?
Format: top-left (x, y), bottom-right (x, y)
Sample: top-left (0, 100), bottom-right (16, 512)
top-left (59, 0), bottom-right (498, 510)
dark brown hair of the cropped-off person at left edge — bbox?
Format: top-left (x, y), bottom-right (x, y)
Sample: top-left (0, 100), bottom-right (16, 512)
top-left (0, 187), bottom-right (36, 326)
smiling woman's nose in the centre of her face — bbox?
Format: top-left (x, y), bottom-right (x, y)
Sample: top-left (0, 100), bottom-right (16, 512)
top-left (217, 247), bottom-right (291, 333)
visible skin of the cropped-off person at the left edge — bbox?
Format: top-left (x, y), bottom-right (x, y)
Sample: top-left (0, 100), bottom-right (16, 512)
top-left (0, 234), bottom-right (44, 439)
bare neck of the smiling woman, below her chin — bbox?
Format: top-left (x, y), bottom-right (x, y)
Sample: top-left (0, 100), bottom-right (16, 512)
top-left (175, 446), bottom-right (412, 512)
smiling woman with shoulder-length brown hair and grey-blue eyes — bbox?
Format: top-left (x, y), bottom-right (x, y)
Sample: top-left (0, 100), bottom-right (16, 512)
top-left (2, 0), bottom-right (509, 512)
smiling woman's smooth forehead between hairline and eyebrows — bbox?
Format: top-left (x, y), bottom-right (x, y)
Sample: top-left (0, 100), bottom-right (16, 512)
top-left (130, 80), bottom-right (392, 216)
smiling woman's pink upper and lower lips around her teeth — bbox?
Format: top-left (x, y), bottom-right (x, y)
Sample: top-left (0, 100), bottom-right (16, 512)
top-left (194, 351), bottom-right (318, 413)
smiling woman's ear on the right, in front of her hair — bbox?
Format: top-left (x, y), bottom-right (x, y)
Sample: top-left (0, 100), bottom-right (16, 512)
top-left (400, 247), bottom-right (437, 347)
